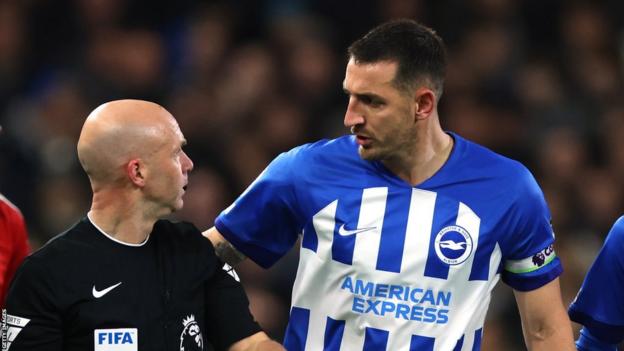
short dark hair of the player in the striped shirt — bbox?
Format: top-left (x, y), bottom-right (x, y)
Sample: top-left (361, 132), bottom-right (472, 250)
top-left (347, 19), bottom-right (446, 99)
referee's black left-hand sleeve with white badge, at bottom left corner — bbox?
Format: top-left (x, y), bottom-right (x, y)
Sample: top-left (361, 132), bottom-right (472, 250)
top-left (6, 257), bottom-right (63, 351)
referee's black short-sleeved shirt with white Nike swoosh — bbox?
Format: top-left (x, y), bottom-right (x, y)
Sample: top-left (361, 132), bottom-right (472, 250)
top-left (7, 218), bottom-right (260, 351)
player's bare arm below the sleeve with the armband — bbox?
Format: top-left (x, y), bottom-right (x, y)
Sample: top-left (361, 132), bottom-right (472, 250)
top-left (514, 278), bottom-right (576, 351)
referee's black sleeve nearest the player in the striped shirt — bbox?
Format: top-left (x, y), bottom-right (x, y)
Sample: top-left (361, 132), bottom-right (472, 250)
top-left (206, 260), bottom-right (262, 351)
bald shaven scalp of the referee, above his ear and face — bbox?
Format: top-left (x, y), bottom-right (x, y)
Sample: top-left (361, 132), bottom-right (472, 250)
top-left (78, 100), bottom-right (179, 185)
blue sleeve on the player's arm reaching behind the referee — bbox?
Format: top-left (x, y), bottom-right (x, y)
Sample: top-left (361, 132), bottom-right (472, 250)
top-left (215, 149), bottom-right (302, 268)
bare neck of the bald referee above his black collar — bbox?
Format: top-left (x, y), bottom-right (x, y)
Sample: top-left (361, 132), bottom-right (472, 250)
top-left (89, 193), bottom-right (156, 244)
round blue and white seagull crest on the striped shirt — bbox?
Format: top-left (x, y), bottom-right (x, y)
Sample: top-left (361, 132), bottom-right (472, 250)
top-left (434, 225), bottom-right (472, 265)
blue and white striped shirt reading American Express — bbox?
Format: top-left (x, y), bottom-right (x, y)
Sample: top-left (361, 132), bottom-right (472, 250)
top-left (216, 134), bottom-right (562, 351)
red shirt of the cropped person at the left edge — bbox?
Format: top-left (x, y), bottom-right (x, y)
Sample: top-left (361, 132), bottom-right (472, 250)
top-left (0, 194), bottom-right (30, 308)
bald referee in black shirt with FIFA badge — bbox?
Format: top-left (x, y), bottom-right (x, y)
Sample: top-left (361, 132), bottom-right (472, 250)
top-left (2, 100), bottom-right (283, 351)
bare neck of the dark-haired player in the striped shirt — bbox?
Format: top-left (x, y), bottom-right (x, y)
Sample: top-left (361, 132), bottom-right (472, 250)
top-left (382, 129), bottom-right (454, 185)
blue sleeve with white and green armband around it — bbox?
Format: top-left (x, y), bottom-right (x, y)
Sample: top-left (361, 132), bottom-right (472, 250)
top-left (501, 166), bottom-right (563, 291)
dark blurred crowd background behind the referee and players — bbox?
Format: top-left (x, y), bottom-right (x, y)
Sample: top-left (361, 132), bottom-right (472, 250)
top-left (0, 0), bottom-right (624, 351)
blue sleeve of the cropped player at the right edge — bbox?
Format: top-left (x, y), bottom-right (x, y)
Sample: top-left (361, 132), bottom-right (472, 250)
top-left (568, 217), bottom-right (624, 344)
